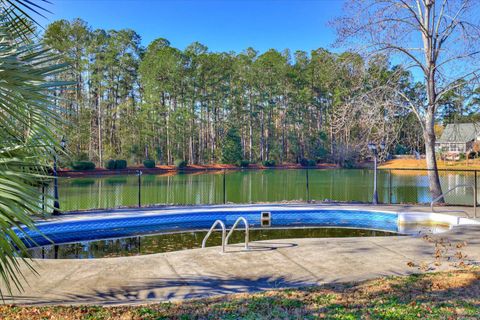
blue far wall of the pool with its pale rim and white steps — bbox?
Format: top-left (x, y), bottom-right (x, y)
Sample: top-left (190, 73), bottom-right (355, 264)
top-left (19, 204), bottom-right (471, 248)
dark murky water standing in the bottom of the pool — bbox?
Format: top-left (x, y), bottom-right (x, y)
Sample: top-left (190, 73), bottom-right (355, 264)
top-left (29, 227), bottom-right (398, 259)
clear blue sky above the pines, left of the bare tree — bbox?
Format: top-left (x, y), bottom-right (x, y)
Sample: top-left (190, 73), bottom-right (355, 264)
top-left (42, 0), bottom-right (343, 52)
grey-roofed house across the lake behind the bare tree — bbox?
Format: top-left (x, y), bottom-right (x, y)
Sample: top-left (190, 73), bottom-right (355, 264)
top-left (435, 123), bottom-right (480, 155)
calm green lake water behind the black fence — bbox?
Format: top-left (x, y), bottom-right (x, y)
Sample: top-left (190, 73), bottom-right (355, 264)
top-left (54, 169), bottom-right (475, 211)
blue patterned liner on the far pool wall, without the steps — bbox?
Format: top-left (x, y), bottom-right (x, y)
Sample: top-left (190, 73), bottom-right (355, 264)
top-left (17, 208), bottom-right (398, 247)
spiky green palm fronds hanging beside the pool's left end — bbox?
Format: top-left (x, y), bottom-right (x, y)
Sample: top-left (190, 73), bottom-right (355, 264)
top-left (0, 0), bottom-right (67, 297)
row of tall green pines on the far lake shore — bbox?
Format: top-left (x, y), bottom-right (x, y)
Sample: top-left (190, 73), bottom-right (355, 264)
top-left (43, 19), bottom-right (479, 165)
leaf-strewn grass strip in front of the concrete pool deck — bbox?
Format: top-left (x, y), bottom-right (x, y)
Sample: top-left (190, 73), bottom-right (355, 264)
top-left (0, 268), bottom-right (480, 320)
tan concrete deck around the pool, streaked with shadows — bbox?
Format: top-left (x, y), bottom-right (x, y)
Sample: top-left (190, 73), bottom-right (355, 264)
top-left (6, 204), bottom-right (480, 305)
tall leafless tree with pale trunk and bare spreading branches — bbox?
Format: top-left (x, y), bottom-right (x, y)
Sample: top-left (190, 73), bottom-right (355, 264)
top-left (334, 0), bottom-right (480, 197)
